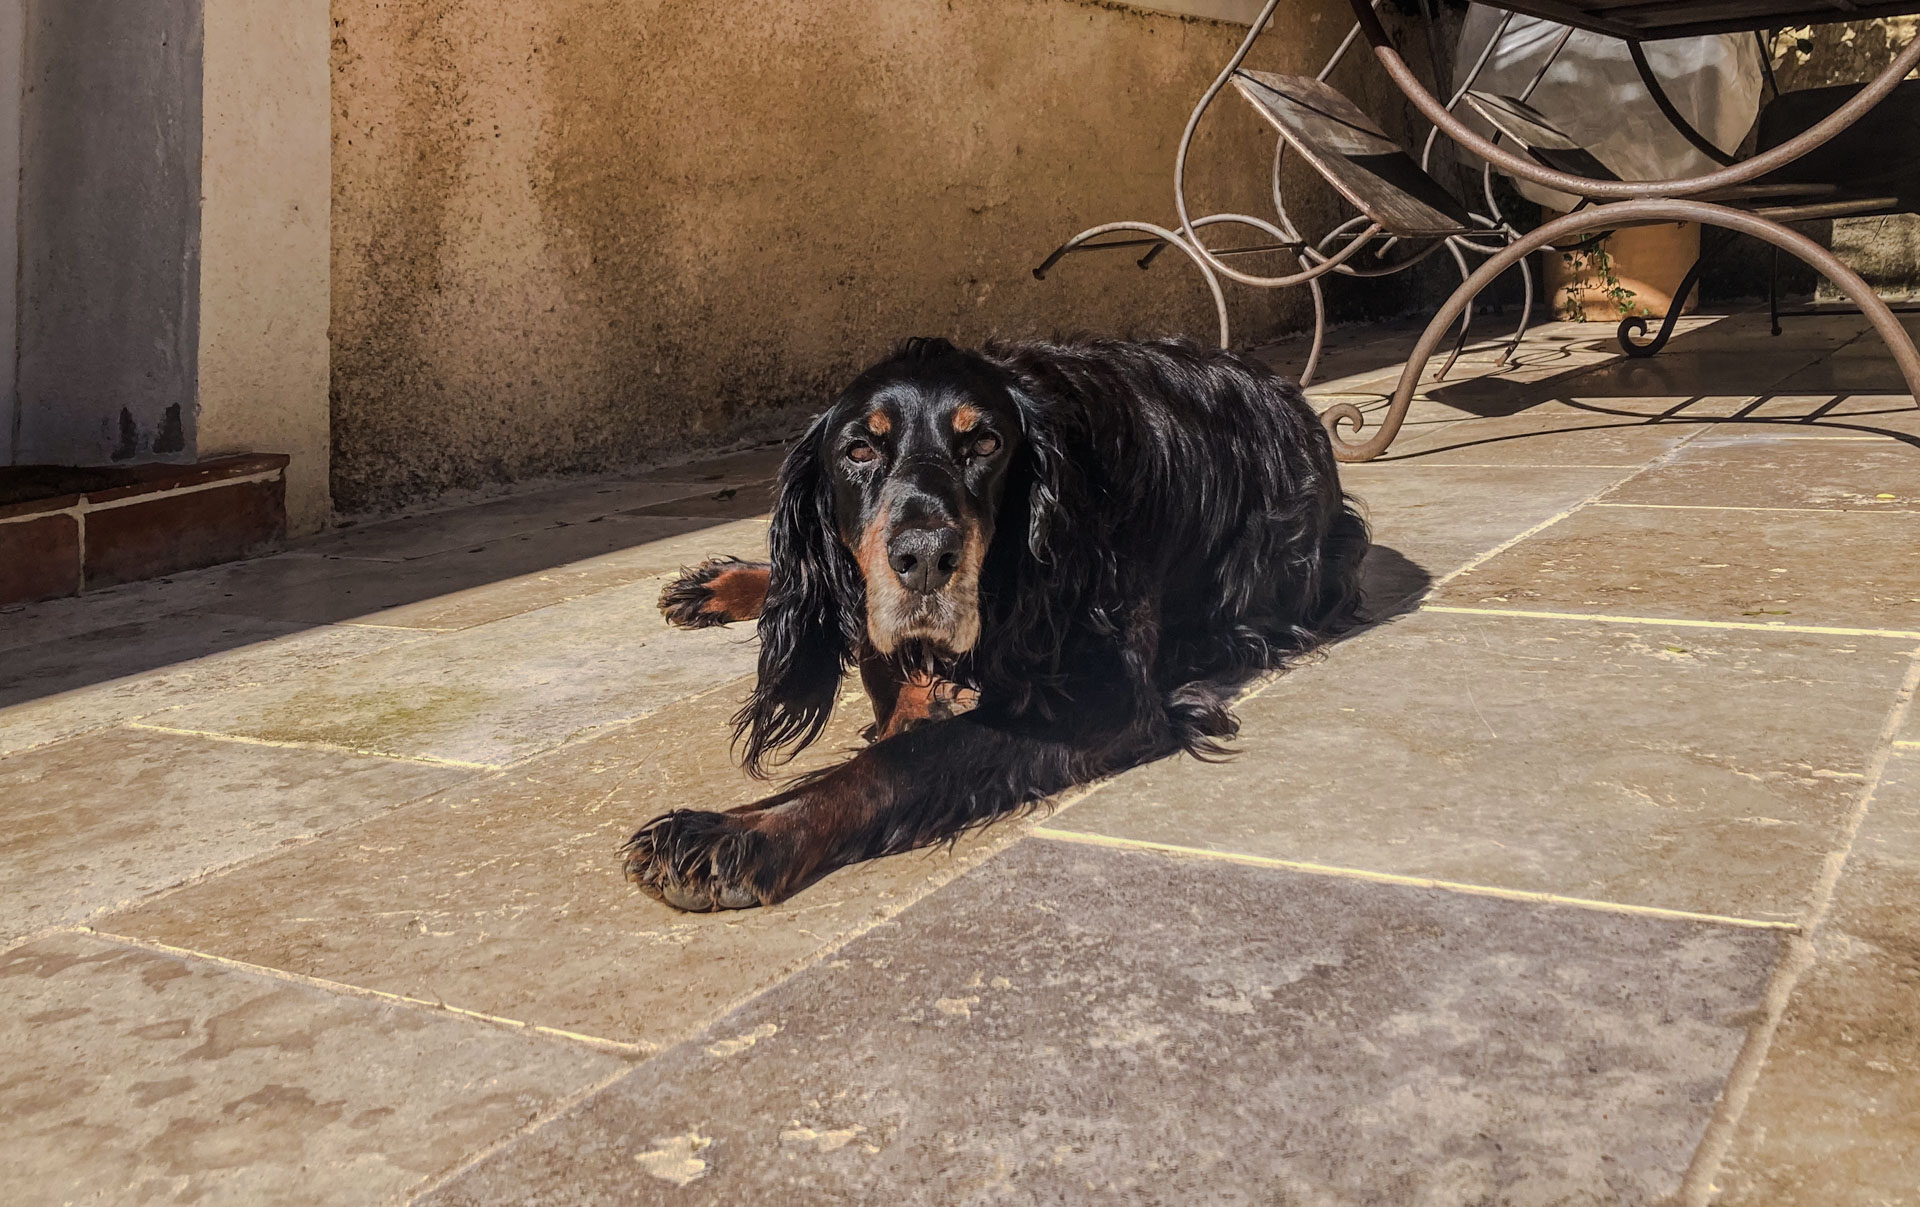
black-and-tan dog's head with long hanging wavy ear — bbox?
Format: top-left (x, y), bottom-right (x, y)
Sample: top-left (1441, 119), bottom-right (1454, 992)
top-left (735, 340), bottom-right (1046, 768)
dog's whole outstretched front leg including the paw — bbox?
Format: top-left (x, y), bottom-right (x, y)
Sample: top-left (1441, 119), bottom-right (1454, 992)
top-left (626, 714), bottom-right (1090, 910)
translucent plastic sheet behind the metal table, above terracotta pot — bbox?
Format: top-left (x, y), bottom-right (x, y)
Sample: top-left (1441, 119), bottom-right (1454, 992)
top-left (1453, 4), bottom-right (1764, 209)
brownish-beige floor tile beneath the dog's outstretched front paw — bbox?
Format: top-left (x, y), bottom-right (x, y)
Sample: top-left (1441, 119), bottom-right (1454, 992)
top-left (98, 683), bottom-right (1020, 1044)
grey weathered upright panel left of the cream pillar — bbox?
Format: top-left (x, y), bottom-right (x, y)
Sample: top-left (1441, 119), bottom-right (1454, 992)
top-left (13, 0), bottom-right (202, 464)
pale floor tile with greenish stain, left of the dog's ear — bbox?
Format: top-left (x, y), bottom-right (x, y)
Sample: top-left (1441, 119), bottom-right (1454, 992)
top-left (153, 574), bottom-right (758, 766)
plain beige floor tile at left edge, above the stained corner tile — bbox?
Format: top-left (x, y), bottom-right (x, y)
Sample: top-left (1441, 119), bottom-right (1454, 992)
top-left (0, 727), bottom-right (472, 940)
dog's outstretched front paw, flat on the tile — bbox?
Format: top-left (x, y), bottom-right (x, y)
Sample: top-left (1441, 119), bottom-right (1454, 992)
top-left (622, 810), bottom-right (776, 913)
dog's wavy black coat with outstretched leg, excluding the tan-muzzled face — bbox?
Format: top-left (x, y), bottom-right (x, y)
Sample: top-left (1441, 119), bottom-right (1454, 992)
top-left (628, 340), bottom-right (1367, 910)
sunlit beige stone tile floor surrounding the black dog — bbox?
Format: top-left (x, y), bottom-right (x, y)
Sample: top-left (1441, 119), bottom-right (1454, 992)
top-left (0, 305), bottom-right (1920, 1207)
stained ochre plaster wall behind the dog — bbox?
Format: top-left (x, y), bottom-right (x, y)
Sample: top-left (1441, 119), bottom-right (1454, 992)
top-left (332, 0), bottom-right (1398, 510)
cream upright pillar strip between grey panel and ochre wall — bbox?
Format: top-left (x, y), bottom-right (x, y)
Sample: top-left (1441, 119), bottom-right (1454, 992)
top-left (196, 0), bottom-right (332, 533)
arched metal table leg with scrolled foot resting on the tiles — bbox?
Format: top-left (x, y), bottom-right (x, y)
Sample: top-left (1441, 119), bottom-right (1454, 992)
top-left (1321, 198), bottom-right (1920, 461)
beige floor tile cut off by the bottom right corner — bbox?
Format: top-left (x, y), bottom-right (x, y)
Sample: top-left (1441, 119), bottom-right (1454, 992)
top-left (1715, 752), bottom-right (1920, 1207)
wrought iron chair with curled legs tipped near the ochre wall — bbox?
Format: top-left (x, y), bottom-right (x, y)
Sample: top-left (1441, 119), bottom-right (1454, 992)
top-left (1033, 0), bottom-right (1546, 386)
